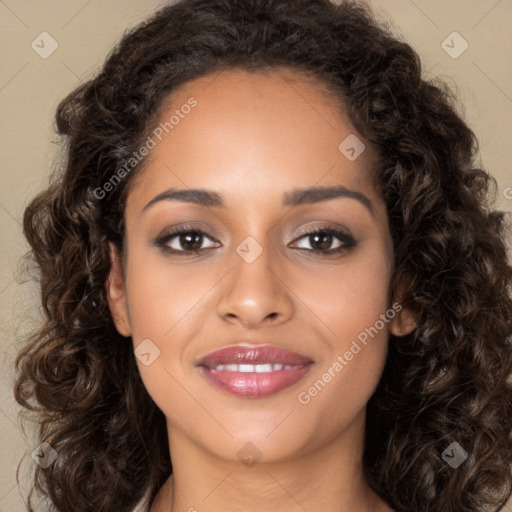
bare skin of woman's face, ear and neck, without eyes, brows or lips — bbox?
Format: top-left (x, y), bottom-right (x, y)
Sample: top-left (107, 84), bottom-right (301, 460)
top-left (107, 70), bottom-right (412, 512)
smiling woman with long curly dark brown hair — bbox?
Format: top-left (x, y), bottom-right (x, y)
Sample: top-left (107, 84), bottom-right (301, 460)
top-left (15, 0), bottom-right (512, 512)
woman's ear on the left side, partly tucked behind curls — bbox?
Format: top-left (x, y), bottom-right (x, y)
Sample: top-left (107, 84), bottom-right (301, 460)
top-left (105, 242), bottom-right (131, 337)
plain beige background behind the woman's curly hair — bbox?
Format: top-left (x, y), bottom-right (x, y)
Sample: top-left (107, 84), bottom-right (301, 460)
top-left (0, 0), bottom-right (512, 512)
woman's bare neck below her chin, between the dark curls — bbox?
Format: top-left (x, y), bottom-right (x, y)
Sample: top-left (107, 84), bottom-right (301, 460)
top-left (150, 410), bottom-right (392, 512)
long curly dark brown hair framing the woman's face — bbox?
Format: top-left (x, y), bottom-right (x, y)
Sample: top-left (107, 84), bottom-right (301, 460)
top-left (15, 0), bottom-right (512, 512)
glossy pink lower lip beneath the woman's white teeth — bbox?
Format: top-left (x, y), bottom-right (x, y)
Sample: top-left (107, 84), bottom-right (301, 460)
top-left (201, 364), bottom-right (311, 398)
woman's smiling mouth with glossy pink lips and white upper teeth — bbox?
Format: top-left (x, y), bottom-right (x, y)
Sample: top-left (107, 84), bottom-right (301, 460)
top-left (197, 345), bottom-right (313, 398)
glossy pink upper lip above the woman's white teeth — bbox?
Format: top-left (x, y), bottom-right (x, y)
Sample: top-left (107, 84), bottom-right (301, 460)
top-left (198, 343), bottom-right (313, 368)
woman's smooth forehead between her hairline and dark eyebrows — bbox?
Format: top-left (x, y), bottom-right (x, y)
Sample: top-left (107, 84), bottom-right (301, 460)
top-left (124, 68), bottom-right (377, 211)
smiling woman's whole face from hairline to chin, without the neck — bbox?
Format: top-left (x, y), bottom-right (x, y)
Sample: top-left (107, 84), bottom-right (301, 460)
top-left (104, 70), bottom-right (404, 462)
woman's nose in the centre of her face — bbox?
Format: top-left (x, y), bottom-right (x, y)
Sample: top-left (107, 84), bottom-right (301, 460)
top-left (217, 243), bottom-right (294, 329)
